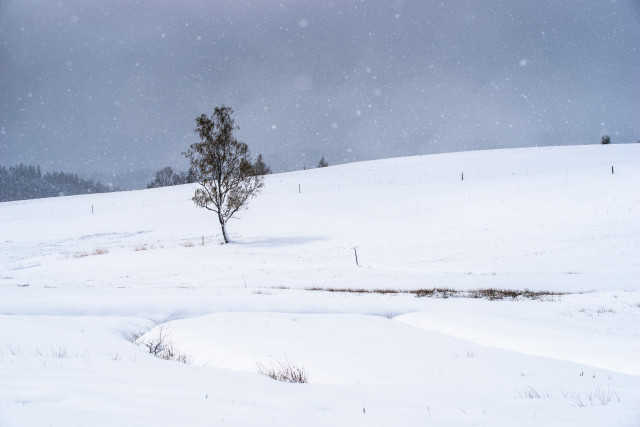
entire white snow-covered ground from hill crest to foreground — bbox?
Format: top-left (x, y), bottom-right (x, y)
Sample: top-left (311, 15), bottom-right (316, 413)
top-left (0, 144), bottom-right (640, 427)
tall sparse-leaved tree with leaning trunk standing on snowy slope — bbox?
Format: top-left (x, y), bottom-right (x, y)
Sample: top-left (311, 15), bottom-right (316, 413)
top-left (182, 105), bottom-right (264, 243)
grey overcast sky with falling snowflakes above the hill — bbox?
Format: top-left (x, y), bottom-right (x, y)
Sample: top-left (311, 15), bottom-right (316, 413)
top-left (0, 0), bottom-right (640, 186)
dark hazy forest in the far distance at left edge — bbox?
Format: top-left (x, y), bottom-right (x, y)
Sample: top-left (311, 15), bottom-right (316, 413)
top-left (0, 164), bottom-right (113, 202)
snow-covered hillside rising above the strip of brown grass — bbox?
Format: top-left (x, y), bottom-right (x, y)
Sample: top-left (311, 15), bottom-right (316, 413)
top-left (0, 145), bottom-right (640, 298)
